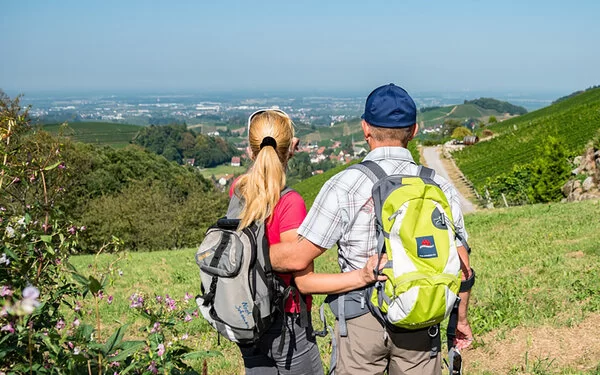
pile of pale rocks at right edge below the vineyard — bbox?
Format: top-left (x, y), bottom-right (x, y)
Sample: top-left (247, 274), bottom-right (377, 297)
top-left (562, 146), bottom-right (600, 202)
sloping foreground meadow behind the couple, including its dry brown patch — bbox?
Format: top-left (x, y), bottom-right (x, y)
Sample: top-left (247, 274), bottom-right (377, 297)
top-left (71, 201), bottom-right (600, 374)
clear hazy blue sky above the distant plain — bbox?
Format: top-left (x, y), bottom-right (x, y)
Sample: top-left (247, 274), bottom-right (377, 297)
top-left (0, 0), bottom-right (600, 93)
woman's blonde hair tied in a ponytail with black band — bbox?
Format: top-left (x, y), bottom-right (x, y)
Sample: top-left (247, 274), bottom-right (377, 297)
top-left (236, 110), bottom-right (294, 230)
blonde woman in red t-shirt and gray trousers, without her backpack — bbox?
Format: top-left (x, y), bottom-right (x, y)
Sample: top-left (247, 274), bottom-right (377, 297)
top-left (230, 109), bottom-right (375, 375)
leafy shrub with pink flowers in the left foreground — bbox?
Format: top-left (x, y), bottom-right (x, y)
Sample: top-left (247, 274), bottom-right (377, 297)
top-left (0, 92), bottom-right (213, 375)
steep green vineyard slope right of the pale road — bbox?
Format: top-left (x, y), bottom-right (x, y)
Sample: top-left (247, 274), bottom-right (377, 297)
top-left (454, 88), bottom-right (600, 189)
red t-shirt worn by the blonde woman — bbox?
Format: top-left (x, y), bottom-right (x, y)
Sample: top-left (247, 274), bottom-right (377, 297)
top-left (229, 181), bottom-right (312, 313)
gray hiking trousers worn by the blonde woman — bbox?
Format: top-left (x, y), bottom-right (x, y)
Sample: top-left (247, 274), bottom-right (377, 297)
top-left (239, 314), bottom-right (323, 375)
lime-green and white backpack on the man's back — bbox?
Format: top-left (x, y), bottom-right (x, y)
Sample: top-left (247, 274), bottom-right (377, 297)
top-left (352, 161), bottom-right (468, 330)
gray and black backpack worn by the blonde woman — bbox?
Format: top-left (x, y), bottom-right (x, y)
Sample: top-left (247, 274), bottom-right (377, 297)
top-left (196, 188), bottom-right (303, 344)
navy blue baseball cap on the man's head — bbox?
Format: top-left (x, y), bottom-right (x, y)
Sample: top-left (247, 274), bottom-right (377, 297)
top-left (361, 83), bottom-right (417, 128)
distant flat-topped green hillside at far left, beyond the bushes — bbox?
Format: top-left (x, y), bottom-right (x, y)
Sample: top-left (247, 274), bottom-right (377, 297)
top-left (43, 122), bottom-right (142, 148)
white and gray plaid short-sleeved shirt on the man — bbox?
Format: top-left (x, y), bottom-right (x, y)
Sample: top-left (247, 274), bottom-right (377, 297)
top-left (298, 147), bottom-right (467, 272)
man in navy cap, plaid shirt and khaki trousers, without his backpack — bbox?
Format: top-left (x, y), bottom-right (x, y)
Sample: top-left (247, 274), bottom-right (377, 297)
top-left (271, 84), bottom-right (472, 375)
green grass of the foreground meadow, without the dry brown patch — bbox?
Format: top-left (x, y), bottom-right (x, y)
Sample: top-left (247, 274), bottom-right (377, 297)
top-left (72, 201), bottom-right (600, 374)
